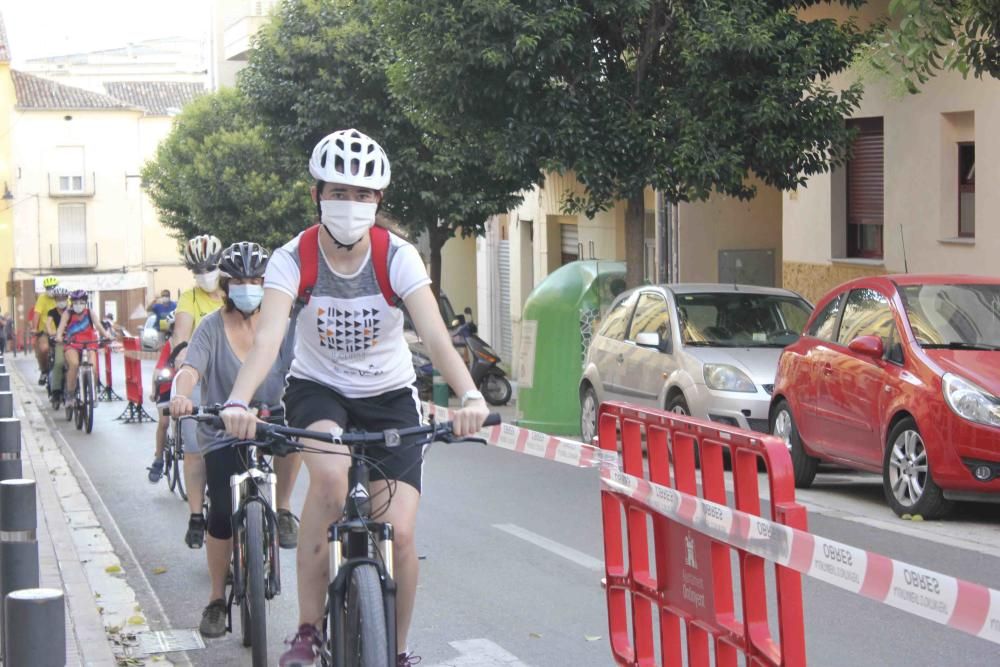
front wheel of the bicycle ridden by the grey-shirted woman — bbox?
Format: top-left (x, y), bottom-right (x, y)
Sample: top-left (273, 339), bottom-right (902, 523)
top-left (240, 502), bottom-right (267, 667)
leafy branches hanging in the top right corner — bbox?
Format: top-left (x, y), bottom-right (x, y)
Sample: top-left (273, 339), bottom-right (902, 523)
top-left (874, 0), bottom-right (1000, 93)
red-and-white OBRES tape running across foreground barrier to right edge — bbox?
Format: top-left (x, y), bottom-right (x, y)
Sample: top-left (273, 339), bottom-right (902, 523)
top-left (601, 465), bottom-right (1000, 644)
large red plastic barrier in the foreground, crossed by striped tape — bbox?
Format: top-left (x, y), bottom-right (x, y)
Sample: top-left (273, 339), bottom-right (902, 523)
top-left (598, 403), bottom-right (806, 667)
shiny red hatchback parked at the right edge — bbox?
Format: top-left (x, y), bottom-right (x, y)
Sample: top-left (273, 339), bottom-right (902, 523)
top-left (770, 274), bottom-right (1000, 519)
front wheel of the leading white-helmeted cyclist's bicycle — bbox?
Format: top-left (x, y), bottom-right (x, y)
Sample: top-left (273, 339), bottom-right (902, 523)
top-left (340, 564), bottom-right (389, 667)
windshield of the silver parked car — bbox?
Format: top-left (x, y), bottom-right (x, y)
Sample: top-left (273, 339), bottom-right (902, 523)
top-left (676, 292), bottom-right (812, 347)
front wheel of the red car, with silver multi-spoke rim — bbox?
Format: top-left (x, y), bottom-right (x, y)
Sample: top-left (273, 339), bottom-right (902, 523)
top-left (882, 417), bottom-right (954, 519)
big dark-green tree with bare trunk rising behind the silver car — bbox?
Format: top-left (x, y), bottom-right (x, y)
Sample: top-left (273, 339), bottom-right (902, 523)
top-left (379, 0), bottom-right (866, 285)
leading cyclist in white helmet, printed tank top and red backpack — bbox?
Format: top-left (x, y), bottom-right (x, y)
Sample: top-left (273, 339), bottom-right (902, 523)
top-left (222, 130), bottom-right (489, 667)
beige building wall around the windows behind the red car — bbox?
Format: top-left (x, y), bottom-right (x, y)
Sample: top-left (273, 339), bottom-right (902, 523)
top-left (783, 7), bottom-right (1000, 295)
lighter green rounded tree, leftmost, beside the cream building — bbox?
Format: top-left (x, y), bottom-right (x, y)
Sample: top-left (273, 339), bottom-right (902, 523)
top-left (142, 89), bottom-right (313, 248)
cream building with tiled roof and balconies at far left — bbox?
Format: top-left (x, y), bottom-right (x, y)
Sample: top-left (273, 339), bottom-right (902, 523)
top-left (7, 70), bottom-right (204, 330)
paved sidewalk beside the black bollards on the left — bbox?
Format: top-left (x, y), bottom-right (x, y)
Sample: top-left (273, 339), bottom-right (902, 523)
top-left (7, 359), bottom-right (168, 667)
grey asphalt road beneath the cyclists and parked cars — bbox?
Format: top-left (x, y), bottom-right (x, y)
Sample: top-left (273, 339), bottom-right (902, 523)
top-left (16, 358), bottom-right (1000, 667)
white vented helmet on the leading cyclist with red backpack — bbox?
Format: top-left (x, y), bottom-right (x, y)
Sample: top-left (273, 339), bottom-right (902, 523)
top-left (309, 130), bottom-right (391, 190)
